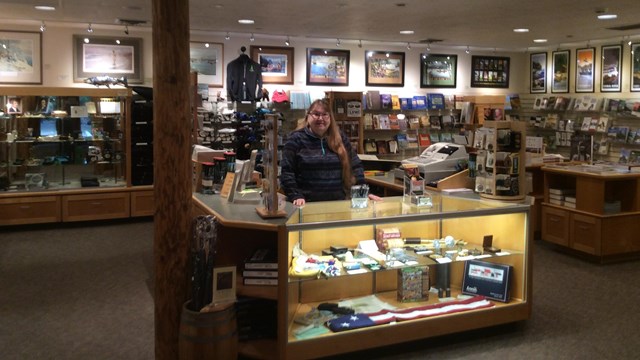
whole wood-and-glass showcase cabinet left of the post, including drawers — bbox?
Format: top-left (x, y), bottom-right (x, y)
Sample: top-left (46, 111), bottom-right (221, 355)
top-left (0, 87), bottom-right (150, 224)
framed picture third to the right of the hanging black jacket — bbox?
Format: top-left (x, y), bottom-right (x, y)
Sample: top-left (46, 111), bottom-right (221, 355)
top-left (364, 50), bottom-right (405, 87)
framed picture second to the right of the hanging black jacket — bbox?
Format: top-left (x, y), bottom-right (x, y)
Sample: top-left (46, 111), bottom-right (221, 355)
top-left (307, 48), bottom-right (350, 86)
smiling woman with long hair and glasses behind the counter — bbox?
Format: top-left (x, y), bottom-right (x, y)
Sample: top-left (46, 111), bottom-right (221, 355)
top-left (280, 100), bottom-right (380, 206)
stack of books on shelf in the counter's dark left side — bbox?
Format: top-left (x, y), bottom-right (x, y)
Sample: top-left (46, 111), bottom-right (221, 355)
top-left (242, 249), bottom-right (278, 286)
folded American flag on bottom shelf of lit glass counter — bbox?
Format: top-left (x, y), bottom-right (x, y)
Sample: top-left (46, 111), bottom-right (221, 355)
top-left (327, 296), bottom-right (494, 332)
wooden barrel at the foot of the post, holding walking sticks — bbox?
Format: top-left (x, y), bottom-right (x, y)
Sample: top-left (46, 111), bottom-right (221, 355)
top-left (179, 302), bottom-right (238, 360)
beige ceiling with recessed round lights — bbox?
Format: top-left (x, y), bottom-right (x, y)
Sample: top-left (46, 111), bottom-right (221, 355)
top-left (0, 0), bottom-right (640, 51)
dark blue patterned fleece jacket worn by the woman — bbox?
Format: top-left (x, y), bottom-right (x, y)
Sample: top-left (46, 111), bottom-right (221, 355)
top-left (280, 127), bottom-right (364, 202)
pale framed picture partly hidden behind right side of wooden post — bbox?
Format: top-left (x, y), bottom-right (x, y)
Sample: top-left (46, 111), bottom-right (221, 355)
top-left (189, 41), bottom-right (224, 87)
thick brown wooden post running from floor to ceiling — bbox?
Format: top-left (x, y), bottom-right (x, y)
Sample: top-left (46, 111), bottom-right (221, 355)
top-left (153, 0), bottom-right (191, 359)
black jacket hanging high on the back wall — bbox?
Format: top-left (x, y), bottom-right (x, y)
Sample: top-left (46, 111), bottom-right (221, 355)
top-left (227, 54), bottom-right (262, 101)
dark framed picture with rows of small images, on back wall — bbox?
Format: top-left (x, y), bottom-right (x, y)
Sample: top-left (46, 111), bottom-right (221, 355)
top-left (471, 55), bottom-right (510, 88)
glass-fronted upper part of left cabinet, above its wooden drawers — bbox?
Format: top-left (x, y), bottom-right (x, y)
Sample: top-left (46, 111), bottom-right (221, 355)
top-left (0, 88), bottom-right (131, 192)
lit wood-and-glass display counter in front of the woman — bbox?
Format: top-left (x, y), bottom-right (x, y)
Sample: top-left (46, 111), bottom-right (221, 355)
top-left (193, 192), bottom-right (531, 359)
